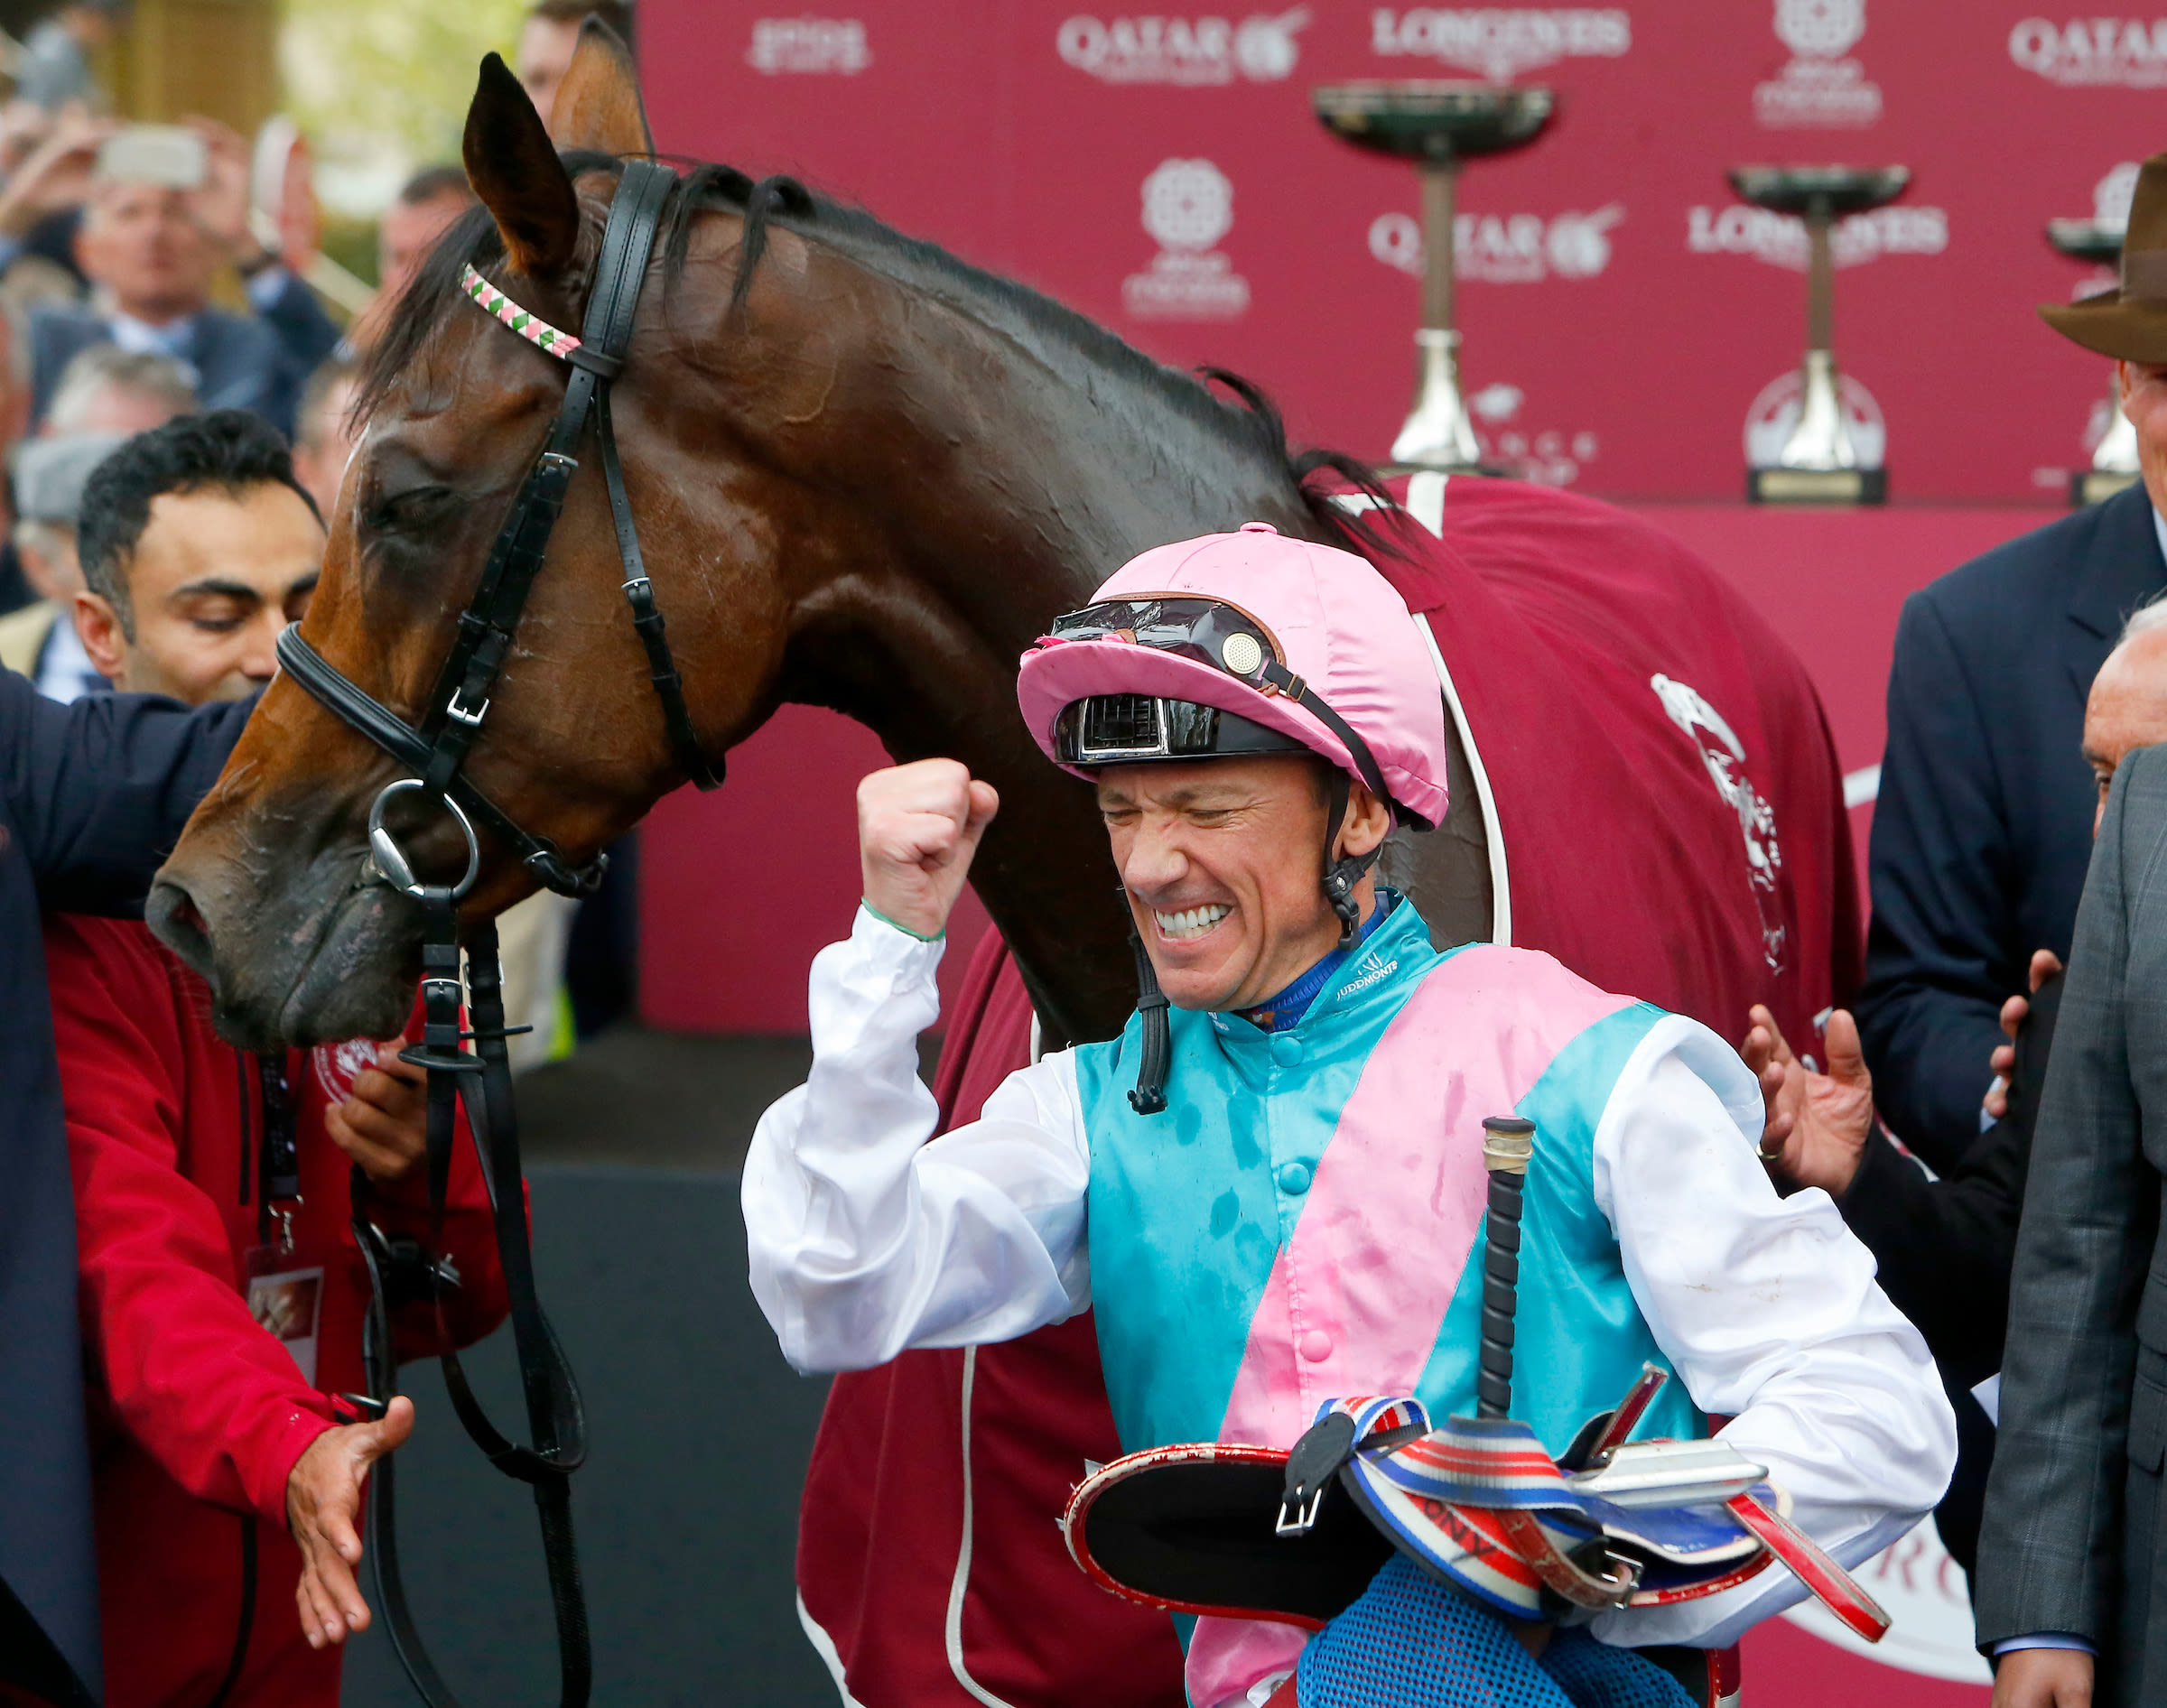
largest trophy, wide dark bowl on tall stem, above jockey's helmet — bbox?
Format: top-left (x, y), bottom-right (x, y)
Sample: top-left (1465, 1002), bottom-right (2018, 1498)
top-left (1311, 82), bottom-right (1556, 475)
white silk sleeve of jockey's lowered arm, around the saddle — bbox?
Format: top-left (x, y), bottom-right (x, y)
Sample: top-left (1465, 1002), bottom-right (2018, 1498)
top-left (1595, 1015), bottom-right (1957, 1648)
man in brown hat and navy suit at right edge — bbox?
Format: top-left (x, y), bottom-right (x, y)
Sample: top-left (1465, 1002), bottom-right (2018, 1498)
top-left (1857, 156), bottom-right (2167, 1173)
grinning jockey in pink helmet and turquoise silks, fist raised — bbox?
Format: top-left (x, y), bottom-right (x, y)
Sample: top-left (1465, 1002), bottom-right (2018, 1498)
top-left (743, 523), bottom-right (1955, 1708)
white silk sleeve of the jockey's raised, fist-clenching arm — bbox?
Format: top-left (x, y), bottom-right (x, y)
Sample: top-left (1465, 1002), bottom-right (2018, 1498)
top-left (743, 908), bottom-right (1090, 1369)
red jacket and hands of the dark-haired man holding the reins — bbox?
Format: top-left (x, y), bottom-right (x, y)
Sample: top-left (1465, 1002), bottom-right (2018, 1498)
top-left (45, 914), bottom-right (505, 1708)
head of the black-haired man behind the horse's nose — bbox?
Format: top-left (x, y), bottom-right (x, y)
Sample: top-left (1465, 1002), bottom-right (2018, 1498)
top-left (76, 410), bottom-right (323, 702)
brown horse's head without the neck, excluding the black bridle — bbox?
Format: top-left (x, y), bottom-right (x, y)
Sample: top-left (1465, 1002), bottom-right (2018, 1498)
top-left (150, 32), bottom-right (817, 1044)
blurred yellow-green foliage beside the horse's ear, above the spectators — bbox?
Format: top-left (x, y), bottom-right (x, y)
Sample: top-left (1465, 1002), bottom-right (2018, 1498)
top-left (280, 0), bottom-right (531, 204)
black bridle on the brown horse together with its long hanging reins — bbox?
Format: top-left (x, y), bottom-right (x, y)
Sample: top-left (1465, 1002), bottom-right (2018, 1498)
top-left (277, 161), bottom-right (721, 1708)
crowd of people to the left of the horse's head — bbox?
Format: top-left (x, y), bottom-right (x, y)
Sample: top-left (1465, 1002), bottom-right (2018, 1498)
top-left (0, 0), bottom-right (630, 1708)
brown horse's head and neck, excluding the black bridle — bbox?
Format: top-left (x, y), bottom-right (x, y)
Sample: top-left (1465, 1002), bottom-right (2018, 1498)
top-left (150, 28), bottom-right (1404, 1044)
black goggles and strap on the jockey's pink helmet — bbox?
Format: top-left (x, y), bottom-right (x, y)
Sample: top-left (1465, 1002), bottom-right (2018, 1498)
top-left (1046, 594), bottom-right (1419, 823)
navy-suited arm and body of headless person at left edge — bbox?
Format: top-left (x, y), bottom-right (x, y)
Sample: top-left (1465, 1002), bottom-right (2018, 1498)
top-left (0, 672), bottom-right (251, 1708)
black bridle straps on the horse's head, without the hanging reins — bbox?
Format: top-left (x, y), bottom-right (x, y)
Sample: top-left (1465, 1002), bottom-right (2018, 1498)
top-left (277, 161), bottom-right (721, 896)
